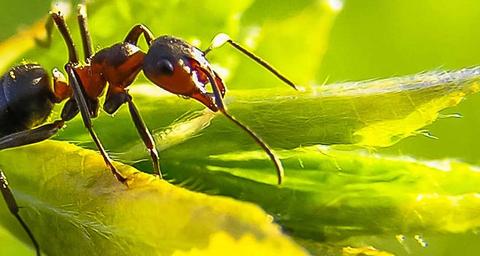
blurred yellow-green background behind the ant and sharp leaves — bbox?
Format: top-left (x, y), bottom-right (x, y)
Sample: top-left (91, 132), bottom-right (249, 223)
top-left (0, 0), bottom-right (480, 255)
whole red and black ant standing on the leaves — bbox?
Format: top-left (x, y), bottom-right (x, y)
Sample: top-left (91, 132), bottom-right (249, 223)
top-left (0, 4), bottom-right (296, 255)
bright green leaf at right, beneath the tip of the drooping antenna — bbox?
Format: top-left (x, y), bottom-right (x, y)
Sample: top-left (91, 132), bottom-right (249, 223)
top-left (133, 147), bottom-right (480, 242)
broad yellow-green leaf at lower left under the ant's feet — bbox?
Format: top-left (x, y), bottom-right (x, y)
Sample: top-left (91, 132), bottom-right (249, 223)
top-left (0, 141), bottom-right (306, 255)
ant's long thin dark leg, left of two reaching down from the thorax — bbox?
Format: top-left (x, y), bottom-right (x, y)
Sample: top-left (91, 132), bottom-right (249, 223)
top-left (65, 63), bottom-right (127, 184)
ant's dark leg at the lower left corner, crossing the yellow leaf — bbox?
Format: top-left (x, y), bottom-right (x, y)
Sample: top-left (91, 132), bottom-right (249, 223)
top-left (0, 170), bottom-right (40, 256)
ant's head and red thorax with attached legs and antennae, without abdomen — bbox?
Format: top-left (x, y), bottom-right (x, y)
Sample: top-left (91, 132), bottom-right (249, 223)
top-left (51, 4), bottom-right (297, 184)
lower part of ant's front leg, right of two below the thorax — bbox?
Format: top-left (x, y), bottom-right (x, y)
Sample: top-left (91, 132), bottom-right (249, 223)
top-left (127, 95), bottom-right (162, 178)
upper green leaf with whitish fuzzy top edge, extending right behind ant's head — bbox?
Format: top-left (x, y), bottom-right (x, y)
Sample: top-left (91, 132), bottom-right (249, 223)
top-left (58, 68), bottom-right (480, 156)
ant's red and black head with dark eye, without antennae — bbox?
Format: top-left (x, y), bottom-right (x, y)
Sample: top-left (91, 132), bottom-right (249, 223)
top-left (143, 36), bottom-right (225, 111)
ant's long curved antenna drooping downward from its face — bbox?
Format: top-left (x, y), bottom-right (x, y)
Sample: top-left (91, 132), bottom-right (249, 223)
top-left (200, 67), bottom-right (284, 185)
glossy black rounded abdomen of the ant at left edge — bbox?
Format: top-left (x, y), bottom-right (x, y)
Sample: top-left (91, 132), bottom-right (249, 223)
top-left (0, 64), bottom-right (53, 137)
